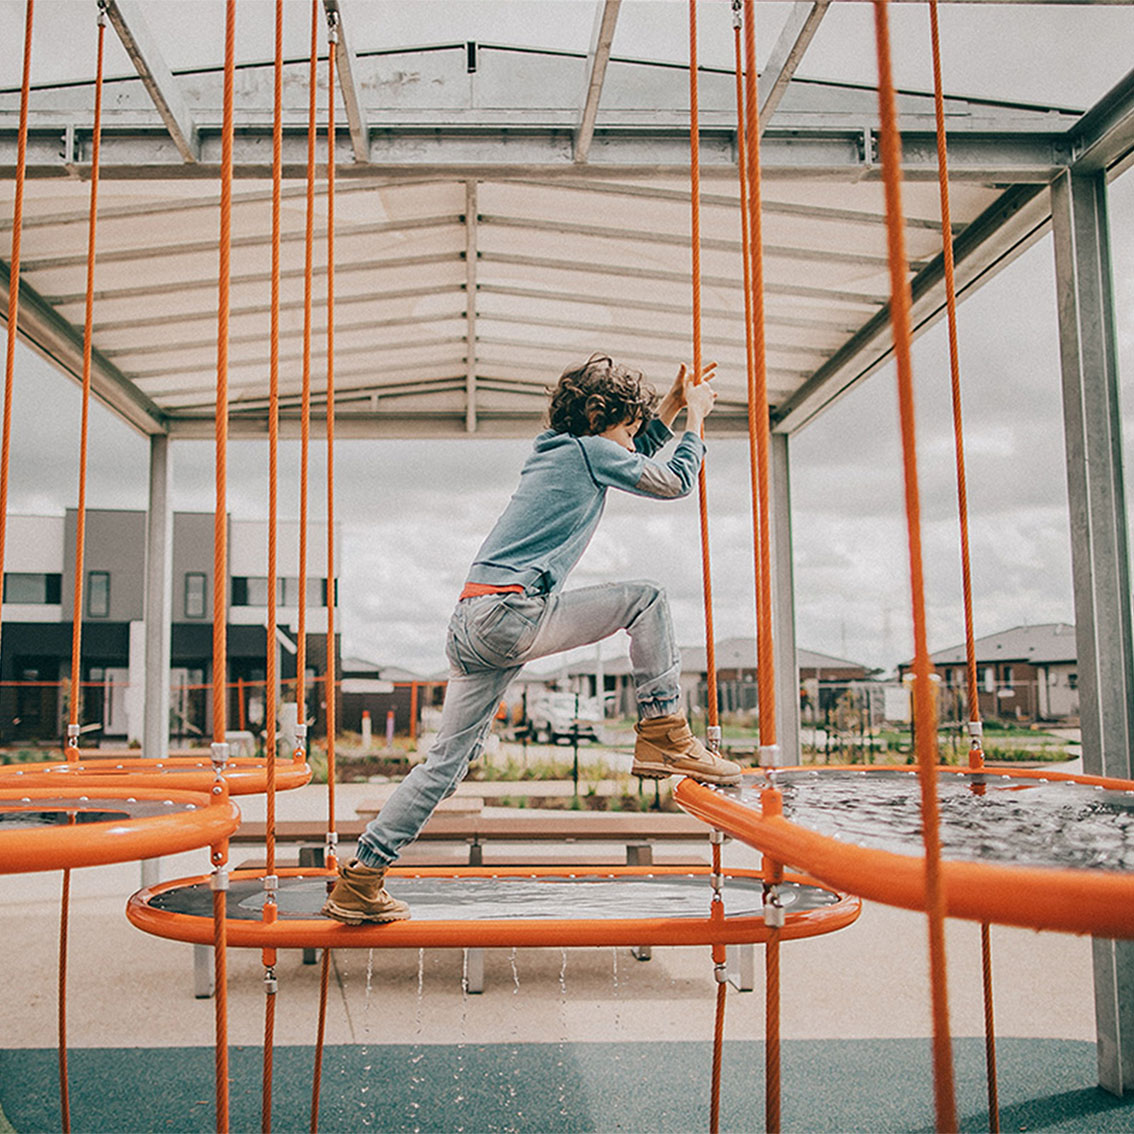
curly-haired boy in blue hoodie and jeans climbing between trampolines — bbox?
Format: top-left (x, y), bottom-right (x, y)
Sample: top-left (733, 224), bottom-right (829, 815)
top-left (323, 355), bottom-right (741, 925)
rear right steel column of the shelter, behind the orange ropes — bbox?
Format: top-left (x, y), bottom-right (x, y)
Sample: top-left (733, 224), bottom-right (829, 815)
top-left (770, 433), bottom-right (799, 764)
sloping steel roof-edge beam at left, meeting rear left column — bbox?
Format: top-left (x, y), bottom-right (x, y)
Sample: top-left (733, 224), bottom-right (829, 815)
top-left (0, 261), bottom-right (166, 434)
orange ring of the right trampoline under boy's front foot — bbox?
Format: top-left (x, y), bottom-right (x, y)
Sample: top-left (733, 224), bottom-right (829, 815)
top-left (674, 764), bottom-right (1134, 938)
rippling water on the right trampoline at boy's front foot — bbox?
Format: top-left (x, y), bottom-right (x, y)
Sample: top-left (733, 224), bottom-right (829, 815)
top-left (720, 769), bottom-right (1134, 871)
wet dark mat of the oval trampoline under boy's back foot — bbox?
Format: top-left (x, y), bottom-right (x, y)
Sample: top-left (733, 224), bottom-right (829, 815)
top-left (149, 873), bottom-right (839, 922)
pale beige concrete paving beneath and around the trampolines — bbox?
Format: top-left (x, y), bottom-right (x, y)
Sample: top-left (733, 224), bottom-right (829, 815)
top-left (0, 785), bottom-right (1120, 1129)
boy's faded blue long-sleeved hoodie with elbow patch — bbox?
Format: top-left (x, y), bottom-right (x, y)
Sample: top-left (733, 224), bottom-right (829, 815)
top-left (467, 418), bottom-right (704, 593)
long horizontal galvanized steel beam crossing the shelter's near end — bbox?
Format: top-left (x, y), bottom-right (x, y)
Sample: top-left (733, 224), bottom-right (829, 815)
top-left (0, 125), bottom-right (1068, 184)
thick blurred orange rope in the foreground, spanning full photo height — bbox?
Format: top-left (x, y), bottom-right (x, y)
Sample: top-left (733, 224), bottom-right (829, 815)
top-left (874, 0), bottom-right (957, 1131)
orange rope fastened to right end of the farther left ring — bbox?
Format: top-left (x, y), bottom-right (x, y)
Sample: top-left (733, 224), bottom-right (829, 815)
top-left (295, 0), bottom-right (319, 739)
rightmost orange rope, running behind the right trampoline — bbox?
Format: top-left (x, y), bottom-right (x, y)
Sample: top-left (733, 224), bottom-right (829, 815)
top-left (929, 0), bottom-right (1000, 1134)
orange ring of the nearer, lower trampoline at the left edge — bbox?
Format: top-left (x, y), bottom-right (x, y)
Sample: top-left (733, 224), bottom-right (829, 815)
top-left (0, 785), bottom-right (240, 874)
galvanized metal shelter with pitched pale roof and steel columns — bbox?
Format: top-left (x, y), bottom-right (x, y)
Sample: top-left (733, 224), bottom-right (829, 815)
top-left (0, 0), bottom-right (1134, 1093)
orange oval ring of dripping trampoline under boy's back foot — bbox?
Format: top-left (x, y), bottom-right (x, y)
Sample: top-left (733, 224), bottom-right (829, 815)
top-left (126, 866), bottom-right (861, 949)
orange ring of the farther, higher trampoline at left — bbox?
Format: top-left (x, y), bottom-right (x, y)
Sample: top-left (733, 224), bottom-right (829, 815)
top-left (0, 755), bottom-right (311, 795)
